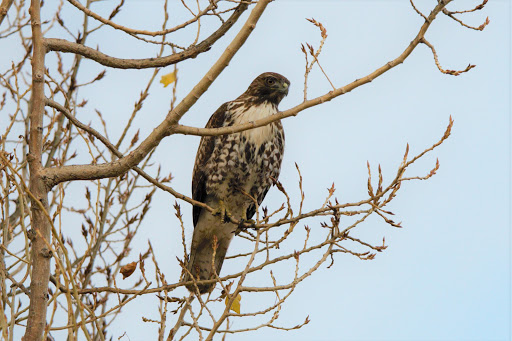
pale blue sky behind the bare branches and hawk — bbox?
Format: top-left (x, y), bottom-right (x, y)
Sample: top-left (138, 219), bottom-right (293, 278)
top-left (2, 0), bottom-right (511, 341)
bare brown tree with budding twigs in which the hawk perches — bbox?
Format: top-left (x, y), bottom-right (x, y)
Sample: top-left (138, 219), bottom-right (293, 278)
top-left (0, 0), bottom-right (488, 341)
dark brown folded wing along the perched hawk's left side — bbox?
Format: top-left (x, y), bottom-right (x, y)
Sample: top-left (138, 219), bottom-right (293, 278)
top-left (192, 103), bottom-right (227, 227)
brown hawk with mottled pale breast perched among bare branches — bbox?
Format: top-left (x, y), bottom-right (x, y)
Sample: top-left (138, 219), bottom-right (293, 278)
top-left (184, 72), bottom-right (290, 294)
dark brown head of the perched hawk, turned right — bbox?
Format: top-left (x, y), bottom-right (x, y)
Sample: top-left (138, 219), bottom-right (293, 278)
top-left (242, 72), bottom-right (290, 106)
